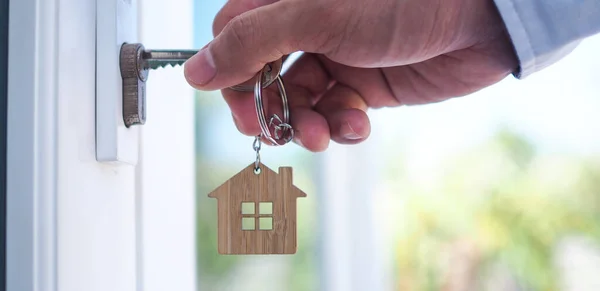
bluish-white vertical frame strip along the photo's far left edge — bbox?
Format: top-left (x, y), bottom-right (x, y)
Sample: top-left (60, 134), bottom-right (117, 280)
top-left (6, 0), bottom-right (58, 291)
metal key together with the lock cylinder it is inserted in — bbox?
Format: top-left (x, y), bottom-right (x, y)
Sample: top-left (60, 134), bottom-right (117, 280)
top-left (120, 43), bottom-right (282, 127)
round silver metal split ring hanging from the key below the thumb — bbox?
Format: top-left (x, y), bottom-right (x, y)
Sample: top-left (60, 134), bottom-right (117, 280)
top-left (254, 64), bottom-right (294, 146)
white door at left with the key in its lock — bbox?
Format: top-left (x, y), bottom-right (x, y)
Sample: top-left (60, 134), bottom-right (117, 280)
top-left (6, 0), bottom-right (195, 291)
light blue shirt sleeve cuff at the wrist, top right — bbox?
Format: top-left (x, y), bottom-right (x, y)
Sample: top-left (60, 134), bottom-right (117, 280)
top-left (494, 0), bottom-right (600, 79)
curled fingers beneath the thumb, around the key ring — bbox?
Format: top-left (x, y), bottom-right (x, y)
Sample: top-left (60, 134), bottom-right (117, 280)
top-left (223, 55), bottom-right (371, 152)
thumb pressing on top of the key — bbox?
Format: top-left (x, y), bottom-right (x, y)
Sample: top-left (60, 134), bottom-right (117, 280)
top-left (185, 0), bottom-right (329, 91)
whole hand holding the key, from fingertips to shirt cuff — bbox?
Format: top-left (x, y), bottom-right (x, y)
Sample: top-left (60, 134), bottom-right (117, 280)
top-left (185, 0), bottom-right (518, 152)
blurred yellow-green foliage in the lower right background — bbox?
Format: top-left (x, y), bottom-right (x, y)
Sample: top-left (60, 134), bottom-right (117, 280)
top-left (390, 130), bottom-right (600, 291)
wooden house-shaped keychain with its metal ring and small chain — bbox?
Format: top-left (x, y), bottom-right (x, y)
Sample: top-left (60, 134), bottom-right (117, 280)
top-left (208, 63), bottom-right (306, 255)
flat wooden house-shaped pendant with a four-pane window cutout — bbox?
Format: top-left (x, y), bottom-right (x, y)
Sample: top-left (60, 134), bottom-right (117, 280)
top-left (208, 163), bottom-right (306, 255)
